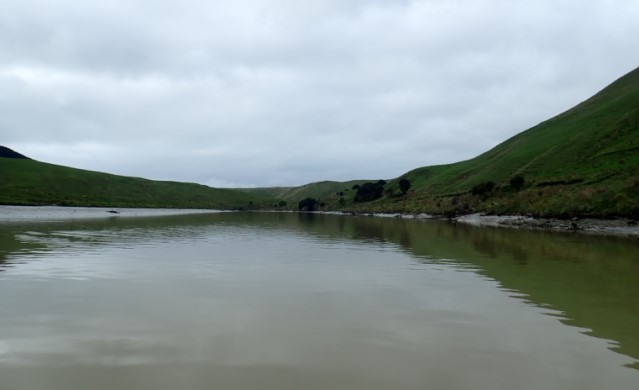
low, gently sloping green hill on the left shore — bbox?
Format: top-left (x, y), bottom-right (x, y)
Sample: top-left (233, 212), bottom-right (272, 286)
top-left (0, 157), bottom-right (269, 209)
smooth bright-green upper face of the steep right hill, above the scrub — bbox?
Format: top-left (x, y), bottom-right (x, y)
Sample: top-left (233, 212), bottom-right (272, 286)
top-left (404, 68), bottom-right (639, 194)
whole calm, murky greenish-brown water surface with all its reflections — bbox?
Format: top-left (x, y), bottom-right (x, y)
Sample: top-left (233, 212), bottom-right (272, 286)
top-left (0, 207), bottom-right (639, 390)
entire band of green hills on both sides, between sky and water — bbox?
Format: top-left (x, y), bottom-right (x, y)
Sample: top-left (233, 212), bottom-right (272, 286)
top-left (0, 68), bottom-right (639, 220)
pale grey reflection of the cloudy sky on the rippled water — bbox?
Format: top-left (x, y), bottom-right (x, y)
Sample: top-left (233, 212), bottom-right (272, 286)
top-left (0, 215), bottom-right (637, 389)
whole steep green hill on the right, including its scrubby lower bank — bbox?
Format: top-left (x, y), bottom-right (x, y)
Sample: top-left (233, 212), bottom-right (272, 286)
top-left (260, 64), bottom-right (639, 217)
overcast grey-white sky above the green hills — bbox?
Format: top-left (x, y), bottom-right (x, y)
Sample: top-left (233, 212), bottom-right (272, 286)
top-left (0, 0), bottom-right (639, 187)
